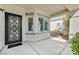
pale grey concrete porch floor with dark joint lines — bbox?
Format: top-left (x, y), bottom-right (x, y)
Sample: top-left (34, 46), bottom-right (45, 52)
top-left (0, 39), bottom-right (72, 55)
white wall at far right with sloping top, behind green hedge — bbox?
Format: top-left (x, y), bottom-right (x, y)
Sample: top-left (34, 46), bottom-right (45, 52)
top-left (69, 11), bottom-right (79, 38)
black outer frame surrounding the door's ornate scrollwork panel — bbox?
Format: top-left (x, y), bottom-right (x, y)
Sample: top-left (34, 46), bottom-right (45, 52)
top-left (5, 12), bottom-right (22, 45)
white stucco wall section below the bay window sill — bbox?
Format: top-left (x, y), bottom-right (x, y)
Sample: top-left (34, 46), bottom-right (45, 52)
top-left (26, 32), bottom-right (50, 41)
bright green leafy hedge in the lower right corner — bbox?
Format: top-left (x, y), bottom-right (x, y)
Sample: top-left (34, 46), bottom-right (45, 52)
top-left (71, 32), bottom-right (79, 55)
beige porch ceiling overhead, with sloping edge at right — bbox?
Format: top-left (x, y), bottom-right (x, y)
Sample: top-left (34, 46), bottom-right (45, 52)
top-left (18, 4), bottom-right (79, 16)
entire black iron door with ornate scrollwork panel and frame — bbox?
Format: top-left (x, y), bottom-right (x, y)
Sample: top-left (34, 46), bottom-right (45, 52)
top-left (5, 12), bottom-right (22, 45)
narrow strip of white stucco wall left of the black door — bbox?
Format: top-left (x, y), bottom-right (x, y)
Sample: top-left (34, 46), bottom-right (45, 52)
top-left (0, 11), bottom-right (5, 49)
